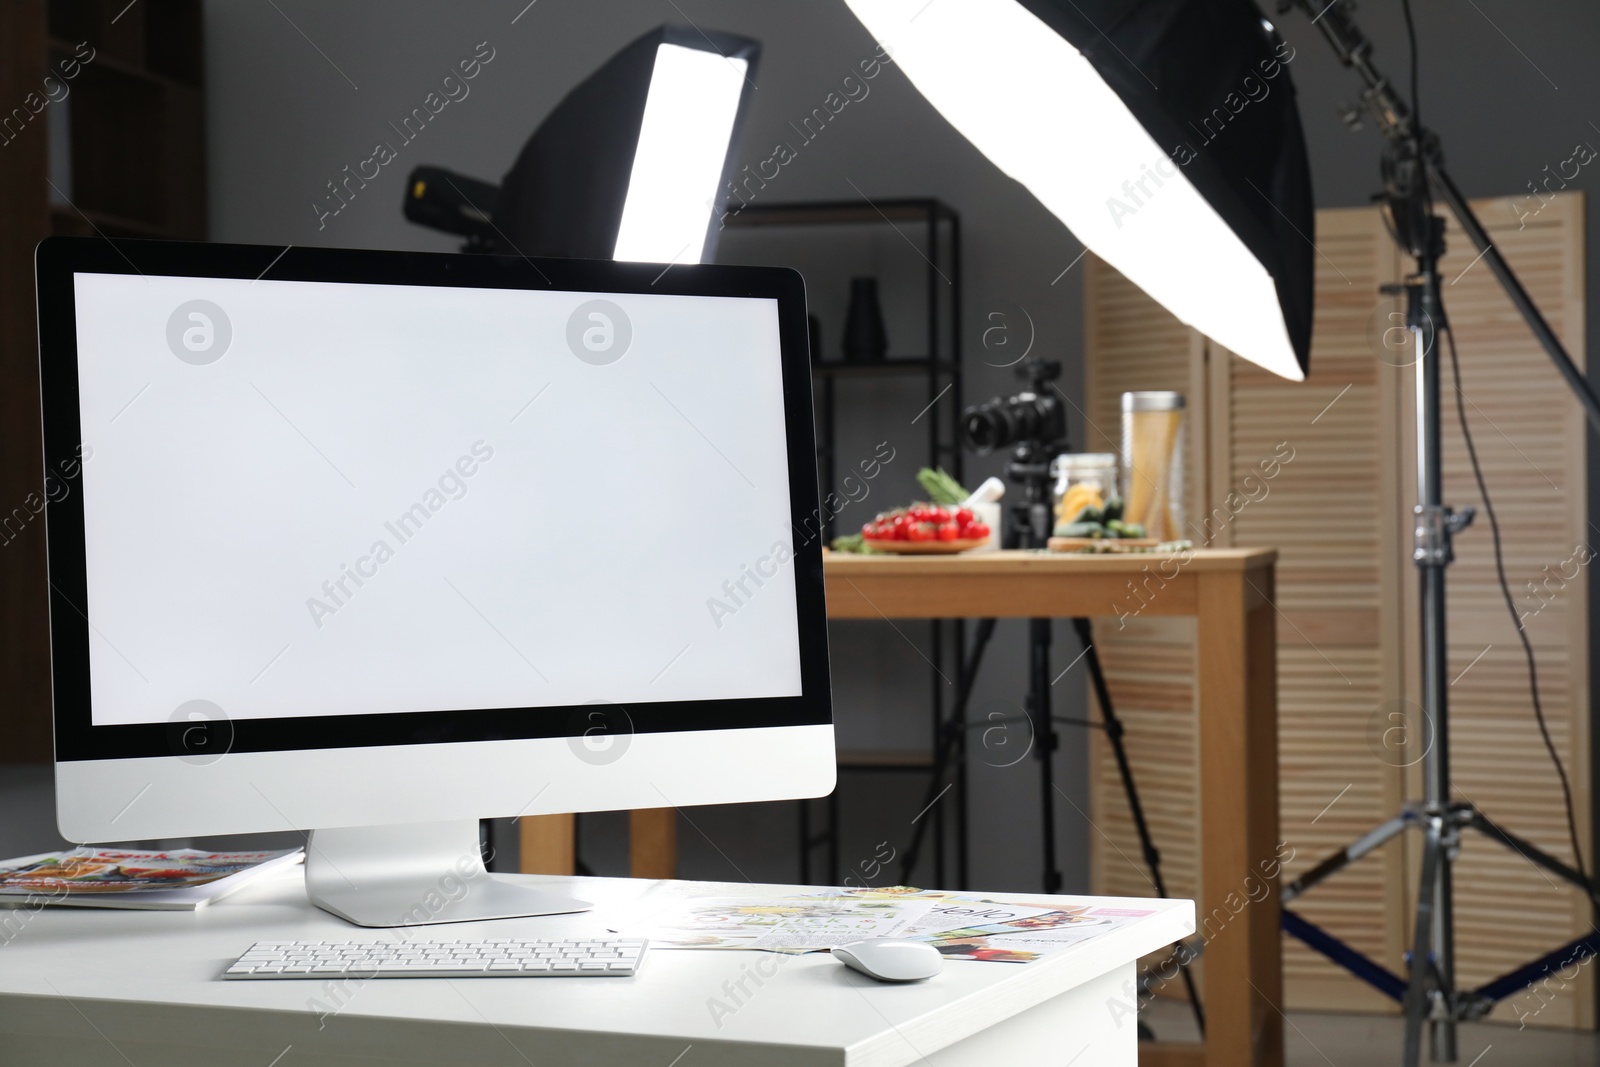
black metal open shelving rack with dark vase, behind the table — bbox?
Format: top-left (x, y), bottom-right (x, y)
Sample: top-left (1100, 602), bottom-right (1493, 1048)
top-left (726, 198), bottom-right (966, 885)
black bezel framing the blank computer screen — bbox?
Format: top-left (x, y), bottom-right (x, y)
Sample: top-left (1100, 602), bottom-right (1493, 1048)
top-left (35, 237), bottom-right (834, 763)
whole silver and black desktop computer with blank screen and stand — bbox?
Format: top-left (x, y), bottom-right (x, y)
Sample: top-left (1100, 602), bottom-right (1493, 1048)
top-left (37, 238), bottom-right (835, 926)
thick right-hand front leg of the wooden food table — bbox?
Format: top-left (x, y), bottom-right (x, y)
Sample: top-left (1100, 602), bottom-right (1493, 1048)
top-left (1195, 568), bottom-right (1283, 1067)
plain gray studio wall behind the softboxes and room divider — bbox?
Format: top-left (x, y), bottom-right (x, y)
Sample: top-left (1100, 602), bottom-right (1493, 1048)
top-left (196, 0), bottom-right (1600, 889)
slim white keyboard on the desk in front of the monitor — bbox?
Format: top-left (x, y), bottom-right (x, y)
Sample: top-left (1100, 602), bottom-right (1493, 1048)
top-left (222, 937), bottom-right (650, 979)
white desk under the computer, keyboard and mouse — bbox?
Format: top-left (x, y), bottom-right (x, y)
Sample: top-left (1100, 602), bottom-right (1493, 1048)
top-left (0, 869), bottom-right (1194, 1067)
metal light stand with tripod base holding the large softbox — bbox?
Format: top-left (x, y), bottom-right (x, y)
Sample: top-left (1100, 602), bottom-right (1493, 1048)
top-left (1280, 0), bottom-right (1600, 1067)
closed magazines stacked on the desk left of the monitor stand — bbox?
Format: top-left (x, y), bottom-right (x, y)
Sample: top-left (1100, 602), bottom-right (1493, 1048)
top-left (0, 848), bottom-right (304, 912)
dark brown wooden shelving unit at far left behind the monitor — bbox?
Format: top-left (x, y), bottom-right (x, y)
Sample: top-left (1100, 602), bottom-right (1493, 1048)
top-left (0, 0), bottom-right (206, 763)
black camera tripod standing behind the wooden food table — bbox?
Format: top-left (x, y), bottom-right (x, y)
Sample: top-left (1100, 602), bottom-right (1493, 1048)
top-left (901, 399), bottom-right (1205, 1033)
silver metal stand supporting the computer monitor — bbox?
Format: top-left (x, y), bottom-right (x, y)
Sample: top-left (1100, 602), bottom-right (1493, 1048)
top-left (306, 819), bottom-right (594, 926)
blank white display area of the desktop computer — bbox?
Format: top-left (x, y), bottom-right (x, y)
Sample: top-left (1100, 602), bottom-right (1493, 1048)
top-left (75, 274), bottom-right (800, 725)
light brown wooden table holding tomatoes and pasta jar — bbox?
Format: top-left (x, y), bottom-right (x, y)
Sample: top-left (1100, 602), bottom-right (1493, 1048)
top-left (523, 549), bottom-right (1283, 1067)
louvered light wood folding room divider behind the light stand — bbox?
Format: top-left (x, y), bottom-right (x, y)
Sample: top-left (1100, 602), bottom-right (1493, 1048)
top-left (1082, 194), bottom-right (1600, 1027)
